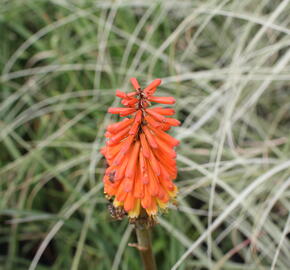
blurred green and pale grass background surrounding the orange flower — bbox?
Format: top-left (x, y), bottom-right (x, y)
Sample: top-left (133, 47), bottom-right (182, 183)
top-left (0, 0), bottom-right (290, 270)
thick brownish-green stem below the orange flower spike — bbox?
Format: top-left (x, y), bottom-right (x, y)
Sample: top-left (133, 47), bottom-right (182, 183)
top-left (136, 226), bottom-right (157, 270)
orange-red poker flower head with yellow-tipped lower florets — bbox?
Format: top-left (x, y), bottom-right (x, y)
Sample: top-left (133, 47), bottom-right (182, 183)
top-left (101, 78), bottom-right (180, 218)
